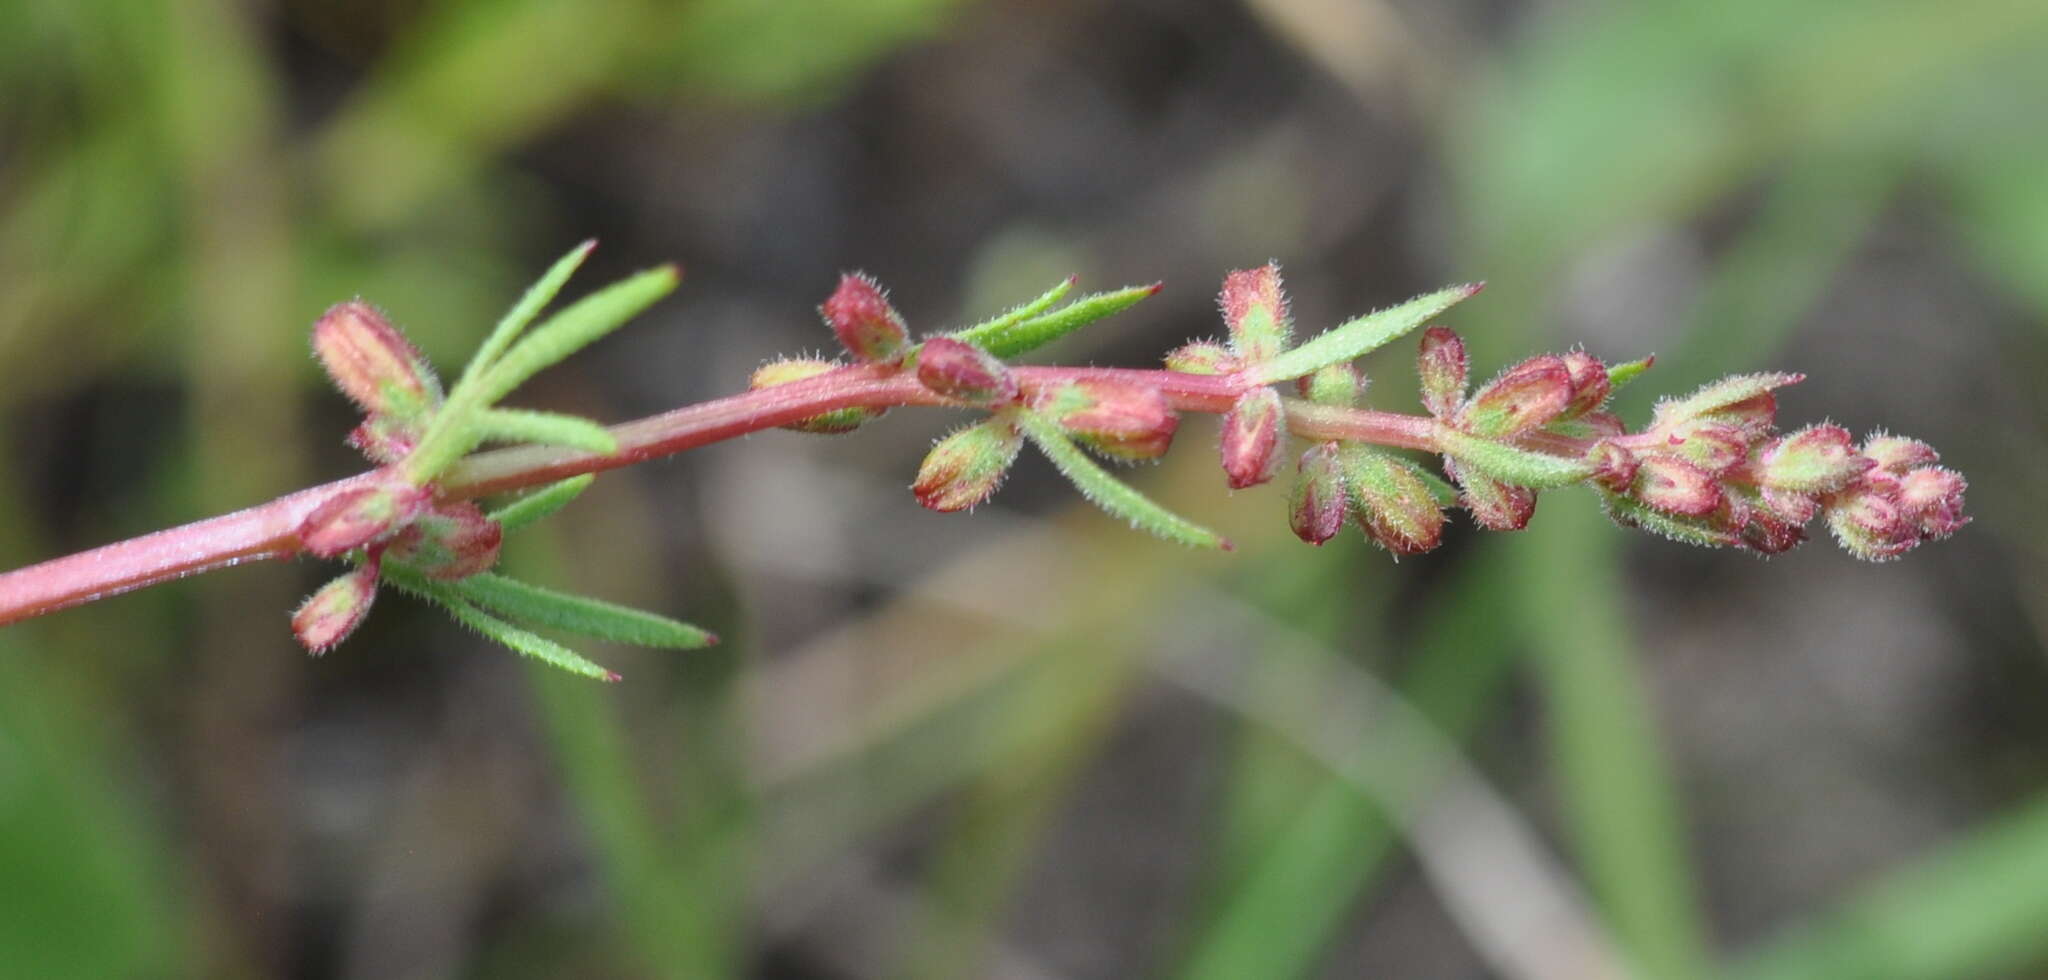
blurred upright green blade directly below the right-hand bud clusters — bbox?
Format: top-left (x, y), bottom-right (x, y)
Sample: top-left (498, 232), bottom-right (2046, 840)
top-left (1509, 493), bottom-right (1712, 980)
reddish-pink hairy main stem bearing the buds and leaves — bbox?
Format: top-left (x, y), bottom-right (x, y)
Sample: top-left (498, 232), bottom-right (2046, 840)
top-left (0, 364), bottom-right (1569, 626)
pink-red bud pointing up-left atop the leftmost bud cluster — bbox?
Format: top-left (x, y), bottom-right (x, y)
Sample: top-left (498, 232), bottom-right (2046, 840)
top-left (313, 301), bottom-right (440, 424)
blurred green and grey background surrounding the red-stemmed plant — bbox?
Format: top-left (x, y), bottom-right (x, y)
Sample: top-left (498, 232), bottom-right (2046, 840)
top-left (0, 0), bottom-right (2048, 980)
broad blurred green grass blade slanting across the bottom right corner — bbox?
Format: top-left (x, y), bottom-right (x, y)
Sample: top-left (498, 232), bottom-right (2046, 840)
top-left (1729, 796), bottom-right (2048, 980)
